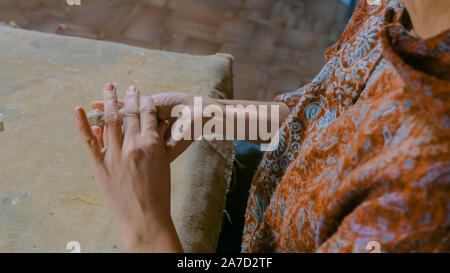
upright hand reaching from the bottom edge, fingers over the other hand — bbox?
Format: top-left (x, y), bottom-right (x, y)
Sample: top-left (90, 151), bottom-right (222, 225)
top-left (75, 84), bottom-right (182, 252)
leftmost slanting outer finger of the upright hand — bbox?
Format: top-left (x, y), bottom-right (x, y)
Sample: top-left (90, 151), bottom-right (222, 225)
top-left (75, 107), bottom-right (103, 164)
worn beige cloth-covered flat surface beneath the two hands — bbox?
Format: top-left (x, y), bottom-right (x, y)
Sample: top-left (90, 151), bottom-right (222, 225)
top-left (0, 27), bottom-right (234, 252)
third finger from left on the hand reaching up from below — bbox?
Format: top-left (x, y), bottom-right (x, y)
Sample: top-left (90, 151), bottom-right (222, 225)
top-left (122, 86), bottom-right (140, 138)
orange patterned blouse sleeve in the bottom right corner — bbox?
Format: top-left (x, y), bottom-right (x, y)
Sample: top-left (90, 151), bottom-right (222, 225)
top-left (318, 171), bottom-right (450, 253)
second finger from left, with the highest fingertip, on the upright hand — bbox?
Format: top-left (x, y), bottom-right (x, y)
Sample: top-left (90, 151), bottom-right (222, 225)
top-left (103, 83), bottom-right (123, 149)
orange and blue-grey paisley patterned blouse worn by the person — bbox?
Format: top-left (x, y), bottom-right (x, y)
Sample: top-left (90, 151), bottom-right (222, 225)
top-left (242, 0), bottom-right (450, 252)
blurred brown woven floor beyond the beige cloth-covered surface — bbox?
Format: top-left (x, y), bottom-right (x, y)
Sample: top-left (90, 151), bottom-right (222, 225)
top-left (0, 0), bottom-right (355, 100)
